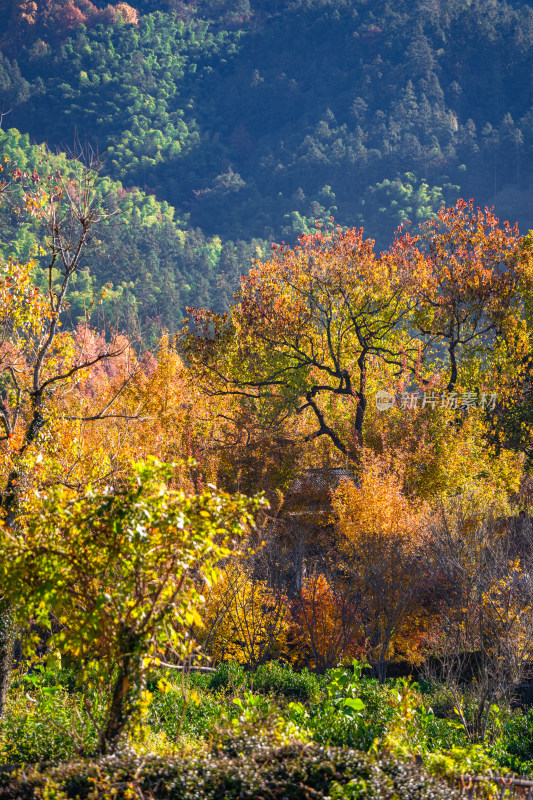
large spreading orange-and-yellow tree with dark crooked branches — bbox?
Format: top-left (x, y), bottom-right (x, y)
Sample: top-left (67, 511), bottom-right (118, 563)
top-left (183, 228), bottom-right (424, 456)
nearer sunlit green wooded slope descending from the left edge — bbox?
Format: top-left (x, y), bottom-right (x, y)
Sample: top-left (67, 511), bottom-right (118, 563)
top-left (0, 130), bottom-right (264, 345)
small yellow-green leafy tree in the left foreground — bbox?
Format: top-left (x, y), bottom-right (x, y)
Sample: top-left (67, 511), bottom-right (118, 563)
top-left (0, 459), bottom-right (260, 753)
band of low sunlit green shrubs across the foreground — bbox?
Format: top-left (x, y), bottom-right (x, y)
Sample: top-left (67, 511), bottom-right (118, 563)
top-left (6, 663), bottom-right (533, 780)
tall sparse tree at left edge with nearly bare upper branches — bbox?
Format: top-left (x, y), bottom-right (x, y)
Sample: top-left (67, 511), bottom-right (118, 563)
top-left (0, 153), bottom-right (142, 713)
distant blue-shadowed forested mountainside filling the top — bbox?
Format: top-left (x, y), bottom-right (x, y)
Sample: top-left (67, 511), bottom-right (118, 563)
top-left (0, 0), bottom-right (533, 323)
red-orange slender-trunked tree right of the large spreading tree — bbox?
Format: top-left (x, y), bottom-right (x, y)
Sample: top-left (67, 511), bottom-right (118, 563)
top-left (410, 200), bottom-right (524, 392)
